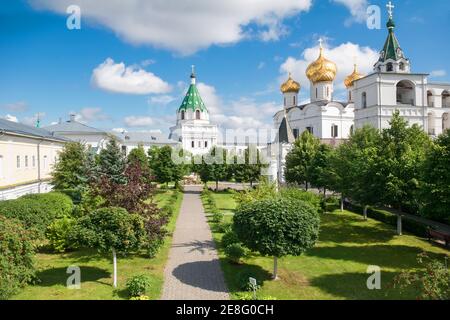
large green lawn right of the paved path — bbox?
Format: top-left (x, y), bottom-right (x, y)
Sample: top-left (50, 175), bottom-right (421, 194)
top-left (206, 193), bottom-right (449, 299)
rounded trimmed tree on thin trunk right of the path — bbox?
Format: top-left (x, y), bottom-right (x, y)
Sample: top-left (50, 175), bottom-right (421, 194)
top-left (233, 198), bottom-right (320, 279)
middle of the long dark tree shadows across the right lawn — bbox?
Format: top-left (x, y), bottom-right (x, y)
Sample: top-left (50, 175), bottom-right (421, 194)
top-left (307, 245), bottom-right (443, 269)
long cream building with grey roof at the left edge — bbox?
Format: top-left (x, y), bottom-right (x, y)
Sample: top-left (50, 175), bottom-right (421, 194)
top-left (0, 119), bottom-right (67, 200)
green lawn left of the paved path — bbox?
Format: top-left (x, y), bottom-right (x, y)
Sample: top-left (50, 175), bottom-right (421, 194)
top-left (13, 190), bottom-right (183, 300)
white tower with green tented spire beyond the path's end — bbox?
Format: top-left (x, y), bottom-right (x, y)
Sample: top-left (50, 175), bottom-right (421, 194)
top-left (169, 69), bottom-right (218, 155)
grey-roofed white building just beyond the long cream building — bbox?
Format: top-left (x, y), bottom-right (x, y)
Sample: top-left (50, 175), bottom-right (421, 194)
top-left (45, 114), bottom-right (109, 153)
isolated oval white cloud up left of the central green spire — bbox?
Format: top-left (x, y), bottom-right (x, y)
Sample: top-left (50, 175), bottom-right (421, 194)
top-left (92, 58), bottom-right (171, 94)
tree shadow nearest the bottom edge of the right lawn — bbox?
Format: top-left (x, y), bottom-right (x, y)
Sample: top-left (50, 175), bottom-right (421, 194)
top-left (310, 270), bottom-right (418, 300)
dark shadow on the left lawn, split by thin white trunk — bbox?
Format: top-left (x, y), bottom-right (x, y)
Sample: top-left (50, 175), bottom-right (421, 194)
top-left (36, 266), bottom-right (111, 287)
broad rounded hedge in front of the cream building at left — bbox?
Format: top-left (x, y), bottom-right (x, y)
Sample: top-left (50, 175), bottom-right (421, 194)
top-left (0, 192), bottom-right (73, 239)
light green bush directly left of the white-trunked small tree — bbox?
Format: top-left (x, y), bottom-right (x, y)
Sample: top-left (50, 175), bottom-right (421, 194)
top-left (45, 217), bottom-right (76, 252)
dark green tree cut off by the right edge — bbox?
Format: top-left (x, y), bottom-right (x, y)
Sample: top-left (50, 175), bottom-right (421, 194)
top-left (420, 130), bottom-right (450, 223)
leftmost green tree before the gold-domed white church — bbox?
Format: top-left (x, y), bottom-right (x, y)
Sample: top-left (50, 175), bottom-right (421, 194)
top-left (284, 131), bottom-right (320, 190)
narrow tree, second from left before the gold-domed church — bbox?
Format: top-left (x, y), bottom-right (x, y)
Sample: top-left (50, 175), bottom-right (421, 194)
top-left (310, 144), bottom-right (334, 195)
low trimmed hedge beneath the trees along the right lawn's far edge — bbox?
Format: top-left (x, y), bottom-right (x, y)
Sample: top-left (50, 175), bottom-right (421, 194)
top-left (345, 202), bottom-right (427, 238)
